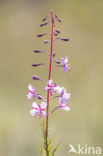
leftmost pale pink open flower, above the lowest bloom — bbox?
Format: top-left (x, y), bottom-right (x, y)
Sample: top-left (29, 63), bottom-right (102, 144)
top-left (27, 84), bottom-right (37, 100)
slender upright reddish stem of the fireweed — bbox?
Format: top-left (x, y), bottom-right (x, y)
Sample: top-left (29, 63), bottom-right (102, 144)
top-left (46, 10), bottom-right (54, 156)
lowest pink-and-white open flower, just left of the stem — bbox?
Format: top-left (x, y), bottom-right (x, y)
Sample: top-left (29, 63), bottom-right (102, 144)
top-left (30, 101), bottom-right (47, 119)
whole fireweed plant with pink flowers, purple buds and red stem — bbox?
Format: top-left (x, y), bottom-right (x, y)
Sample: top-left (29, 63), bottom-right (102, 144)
top-left (27, 10), bottom-right (71, 156)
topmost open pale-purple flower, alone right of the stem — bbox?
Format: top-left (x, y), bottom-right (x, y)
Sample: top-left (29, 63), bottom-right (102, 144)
top-left (61, 56), bottom-right (70, 73)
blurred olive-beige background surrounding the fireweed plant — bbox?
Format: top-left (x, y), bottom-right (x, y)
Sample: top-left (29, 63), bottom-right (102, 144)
top-left (0, 0), bottom-right (103, 156)
